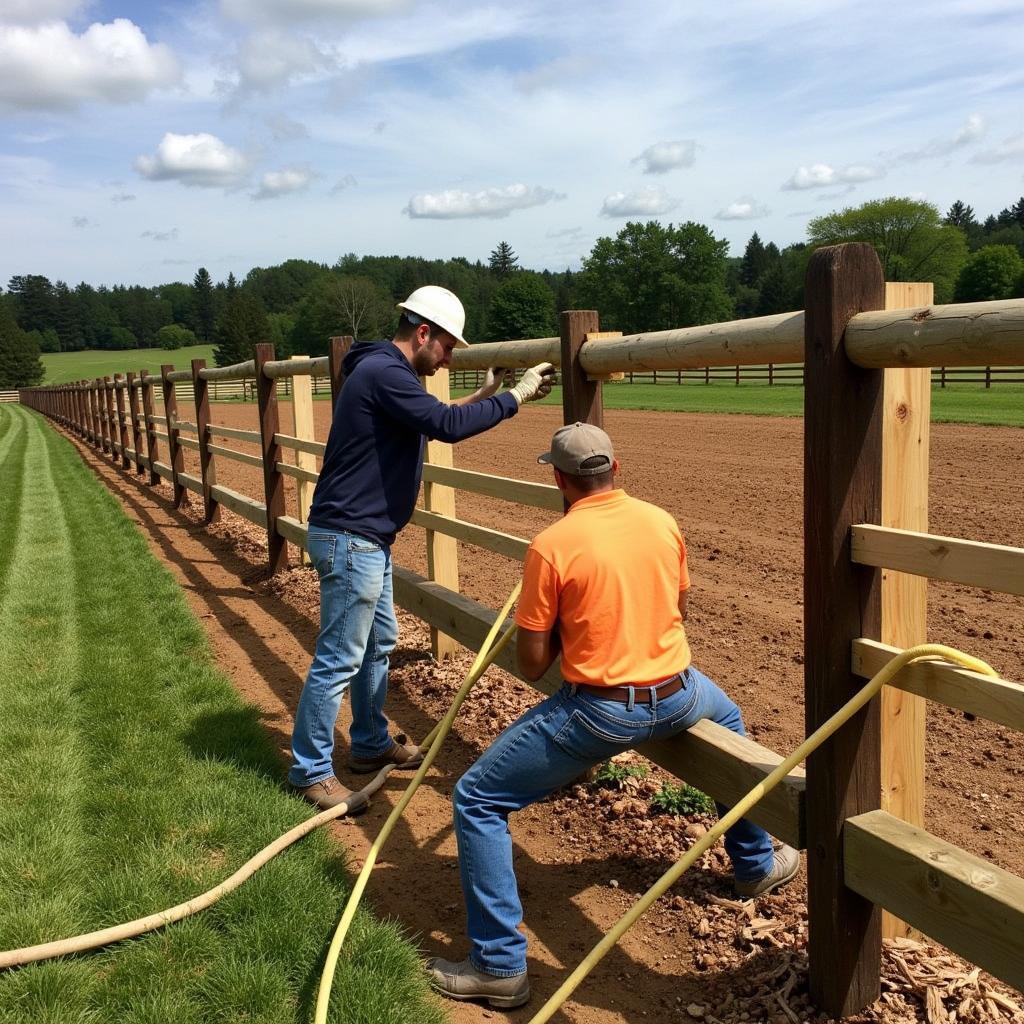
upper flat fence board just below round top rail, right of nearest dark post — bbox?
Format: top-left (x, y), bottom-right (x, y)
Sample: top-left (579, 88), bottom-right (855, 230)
top-left (850, 524), bottom-right (1024, 595)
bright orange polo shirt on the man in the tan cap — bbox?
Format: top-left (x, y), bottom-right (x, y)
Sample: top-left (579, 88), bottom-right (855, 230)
top-left (515, 490), bottom-right (690, 686)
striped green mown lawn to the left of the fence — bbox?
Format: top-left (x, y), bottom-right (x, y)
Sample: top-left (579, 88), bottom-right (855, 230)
top-left (0, 406), bottom-right (443, 1024)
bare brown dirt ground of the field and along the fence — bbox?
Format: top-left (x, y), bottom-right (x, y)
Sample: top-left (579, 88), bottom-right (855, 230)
top-left (64, 402), bottom-right (1024, 1024)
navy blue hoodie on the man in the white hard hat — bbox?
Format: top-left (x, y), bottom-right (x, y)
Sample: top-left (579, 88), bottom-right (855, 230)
top-left (309, 341), bottom-right (519, 545)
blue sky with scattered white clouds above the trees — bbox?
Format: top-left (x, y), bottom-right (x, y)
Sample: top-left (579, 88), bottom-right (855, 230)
top-left (0, 0), bottom-right (1024, 284)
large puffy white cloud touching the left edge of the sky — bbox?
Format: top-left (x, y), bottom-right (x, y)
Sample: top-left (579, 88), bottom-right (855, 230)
top-left (0, 17), bottom-right (181, 110)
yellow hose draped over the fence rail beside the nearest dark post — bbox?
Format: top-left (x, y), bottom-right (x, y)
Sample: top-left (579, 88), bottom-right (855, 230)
top-left (524, 643), bottom-right (997, 1024)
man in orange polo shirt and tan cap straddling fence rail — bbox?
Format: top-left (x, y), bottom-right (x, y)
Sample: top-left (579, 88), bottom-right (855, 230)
top-left (430, 423), bottom-right (800, 1009)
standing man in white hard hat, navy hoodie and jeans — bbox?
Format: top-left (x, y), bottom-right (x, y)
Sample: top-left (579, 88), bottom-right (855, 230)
top-left (288, 285), bottom-right (554, 813)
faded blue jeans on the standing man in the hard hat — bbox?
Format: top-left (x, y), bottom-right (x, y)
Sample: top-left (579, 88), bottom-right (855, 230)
top-left (288, 525), bottom-right (398, 787)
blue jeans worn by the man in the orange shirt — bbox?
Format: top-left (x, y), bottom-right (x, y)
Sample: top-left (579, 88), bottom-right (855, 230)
top-left (452, 667), bottom-right (773, 977)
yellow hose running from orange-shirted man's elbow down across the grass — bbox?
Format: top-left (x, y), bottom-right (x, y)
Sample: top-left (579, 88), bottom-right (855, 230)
top-left (313, 583), bottom-right (522, 1024)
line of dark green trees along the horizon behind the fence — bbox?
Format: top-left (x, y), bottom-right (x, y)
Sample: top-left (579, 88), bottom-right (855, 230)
top-left (0, 197), bottom-right (1024, 387)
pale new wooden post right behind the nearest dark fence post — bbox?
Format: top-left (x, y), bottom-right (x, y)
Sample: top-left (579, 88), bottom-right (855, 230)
top-left (882, 282), bottom-right (935, 938)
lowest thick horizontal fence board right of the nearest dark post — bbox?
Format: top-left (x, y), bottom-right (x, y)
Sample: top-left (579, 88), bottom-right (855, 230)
top-left (844, 811), bottom-right (1024, 989)
